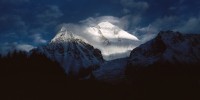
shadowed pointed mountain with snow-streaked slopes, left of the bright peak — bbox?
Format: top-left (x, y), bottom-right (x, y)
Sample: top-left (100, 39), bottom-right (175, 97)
top-left (34, 30), bottom-right (104, 76)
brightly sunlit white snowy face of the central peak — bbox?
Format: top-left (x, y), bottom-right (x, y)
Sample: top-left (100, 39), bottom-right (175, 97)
top-left (87, 22), bottom-right (139, 60)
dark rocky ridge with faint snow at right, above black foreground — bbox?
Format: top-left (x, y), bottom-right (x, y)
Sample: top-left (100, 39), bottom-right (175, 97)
top-left (129, 31), bottom-right (200, 66)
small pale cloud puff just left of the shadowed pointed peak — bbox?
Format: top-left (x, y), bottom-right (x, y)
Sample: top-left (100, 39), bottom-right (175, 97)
top-left (32, 34), bottom-right (47, 44)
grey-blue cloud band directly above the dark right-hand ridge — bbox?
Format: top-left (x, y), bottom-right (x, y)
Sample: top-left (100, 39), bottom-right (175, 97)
top-left (151, 16), bottom-right (200, 33)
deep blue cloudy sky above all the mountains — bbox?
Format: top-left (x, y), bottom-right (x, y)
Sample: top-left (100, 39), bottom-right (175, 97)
top-left (0, 0), bottom-right (200, 53)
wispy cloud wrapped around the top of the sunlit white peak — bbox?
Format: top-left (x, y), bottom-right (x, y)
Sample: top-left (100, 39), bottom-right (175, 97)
top-left (59, 15), bottom-right (153, 44)
